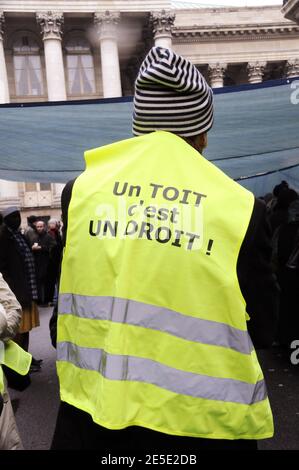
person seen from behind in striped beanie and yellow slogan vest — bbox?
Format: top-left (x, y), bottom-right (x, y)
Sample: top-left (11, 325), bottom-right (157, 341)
top-left (52, 47), bottom-right (277, 453)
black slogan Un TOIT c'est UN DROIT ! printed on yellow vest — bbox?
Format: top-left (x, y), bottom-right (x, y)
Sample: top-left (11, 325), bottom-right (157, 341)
top-left (88, 181), bottom-right (214, 256)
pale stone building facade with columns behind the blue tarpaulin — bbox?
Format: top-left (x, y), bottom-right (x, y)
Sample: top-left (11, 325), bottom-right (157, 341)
top-left (0, 0), bottom-right (299, 224)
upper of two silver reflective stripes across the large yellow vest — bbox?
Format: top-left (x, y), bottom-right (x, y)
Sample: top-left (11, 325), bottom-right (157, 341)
top-left (58, 294), bottom-right (253, 354)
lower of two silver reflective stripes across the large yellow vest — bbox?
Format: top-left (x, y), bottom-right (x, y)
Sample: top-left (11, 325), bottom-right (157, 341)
top-left (57, 342), bottom-right (267, 405)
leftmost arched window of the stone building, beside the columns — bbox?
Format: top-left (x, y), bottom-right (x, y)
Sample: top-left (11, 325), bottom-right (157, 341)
top-left (13, 33), bottom-right (44, 96)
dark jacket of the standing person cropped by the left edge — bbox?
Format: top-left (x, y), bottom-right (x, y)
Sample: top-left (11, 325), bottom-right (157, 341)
top-left (0, 225), bottom-right (32, 308)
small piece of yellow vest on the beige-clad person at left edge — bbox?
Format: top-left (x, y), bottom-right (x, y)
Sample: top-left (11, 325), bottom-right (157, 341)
top-left (0, 340), bottom-right (32, 394)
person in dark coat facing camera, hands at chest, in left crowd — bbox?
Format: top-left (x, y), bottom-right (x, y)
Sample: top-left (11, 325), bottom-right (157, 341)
top-left (30, 220), bottom-right (56, 305)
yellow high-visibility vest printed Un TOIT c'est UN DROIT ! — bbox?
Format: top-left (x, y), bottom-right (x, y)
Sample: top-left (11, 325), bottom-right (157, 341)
top-left (57, 131), bottom-right (273, 439)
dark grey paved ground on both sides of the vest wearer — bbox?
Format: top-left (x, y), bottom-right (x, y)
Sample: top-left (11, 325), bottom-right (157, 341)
top-left (11, 308), bottom-right (299, 450)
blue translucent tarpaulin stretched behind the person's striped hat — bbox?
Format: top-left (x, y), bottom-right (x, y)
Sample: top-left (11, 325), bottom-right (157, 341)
top-left (0, 78), bottom-right (299, 196)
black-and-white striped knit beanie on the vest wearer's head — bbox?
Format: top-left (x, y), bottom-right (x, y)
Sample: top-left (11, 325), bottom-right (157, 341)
top-left (133, 47), bottom-right (213, 137)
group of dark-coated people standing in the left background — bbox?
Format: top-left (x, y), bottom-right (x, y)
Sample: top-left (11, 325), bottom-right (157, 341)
top-left (0, 211), bottom-right (62, 372)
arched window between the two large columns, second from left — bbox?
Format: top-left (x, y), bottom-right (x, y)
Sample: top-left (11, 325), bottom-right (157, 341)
top-left (65, 37), bottom-right (96, 96)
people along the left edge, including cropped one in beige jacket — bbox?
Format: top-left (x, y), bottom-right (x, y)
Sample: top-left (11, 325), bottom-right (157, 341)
top-left (0, 206), bottom-right (62, 450)
